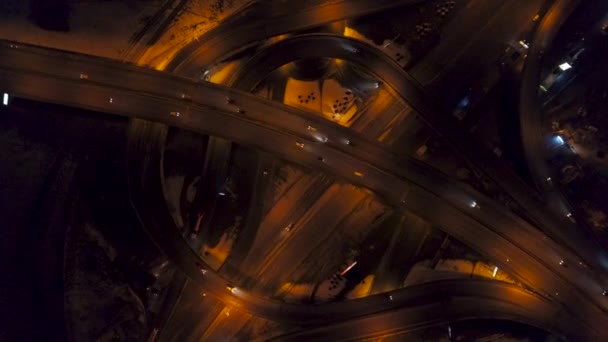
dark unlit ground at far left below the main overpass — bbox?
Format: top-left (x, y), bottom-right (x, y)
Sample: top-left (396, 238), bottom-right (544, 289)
top-left (0, 99), bottom-right (154, 341)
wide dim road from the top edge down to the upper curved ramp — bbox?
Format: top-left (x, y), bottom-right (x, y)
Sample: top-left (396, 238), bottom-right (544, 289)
top-left (408, 0), bottom-right (546, 99)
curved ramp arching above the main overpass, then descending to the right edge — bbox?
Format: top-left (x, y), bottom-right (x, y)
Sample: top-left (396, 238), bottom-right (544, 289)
top-left (230, 32), bottom-right (608, 281)
